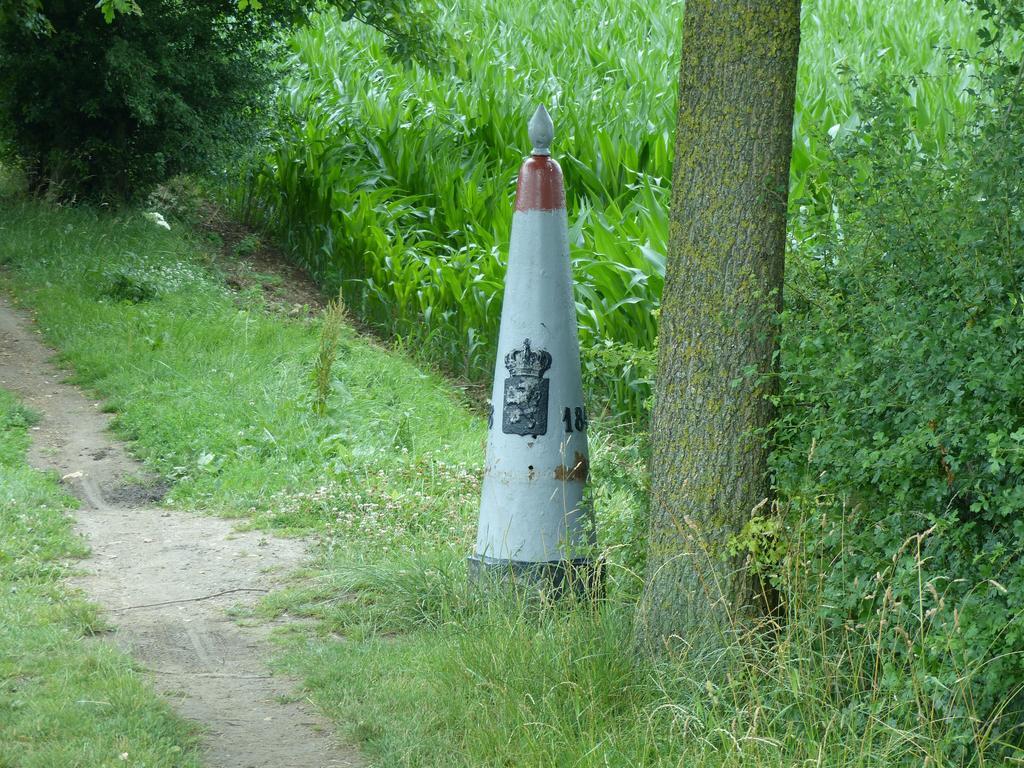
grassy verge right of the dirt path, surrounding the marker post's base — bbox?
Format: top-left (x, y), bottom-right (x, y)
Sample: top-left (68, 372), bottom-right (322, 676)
top-left (0, 203), bottom-right (1013, 768)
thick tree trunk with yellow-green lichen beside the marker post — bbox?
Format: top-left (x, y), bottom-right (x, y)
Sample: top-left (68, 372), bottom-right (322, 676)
top-left (638, 0), bottom-right (800, 650)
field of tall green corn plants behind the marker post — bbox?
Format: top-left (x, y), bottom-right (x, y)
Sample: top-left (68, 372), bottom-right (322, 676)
top-left (235, 0), bottom-right (977, 422)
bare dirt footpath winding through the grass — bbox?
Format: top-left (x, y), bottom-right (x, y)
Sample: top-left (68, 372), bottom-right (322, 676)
top-left (0, 296), bottom-right (365, 768)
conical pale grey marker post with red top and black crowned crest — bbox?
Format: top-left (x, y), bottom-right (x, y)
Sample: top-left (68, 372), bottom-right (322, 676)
top-left (469, 105), bottom-right (594, 589)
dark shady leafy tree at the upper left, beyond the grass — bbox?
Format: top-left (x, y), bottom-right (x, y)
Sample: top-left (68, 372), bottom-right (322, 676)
top-left (0, 0), bottom-right (433, 200)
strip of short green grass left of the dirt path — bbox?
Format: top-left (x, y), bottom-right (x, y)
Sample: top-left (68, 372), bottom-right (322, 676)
top-left (0, 390), bottom-right (199, 768)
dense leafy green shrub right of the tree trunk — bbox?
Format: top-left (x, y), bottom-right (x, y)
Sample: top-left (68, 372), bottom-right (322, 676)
top-left (774, 28), bottom-right (1024, 760)
